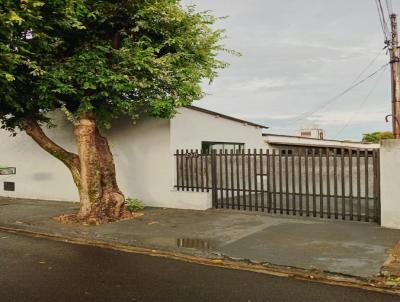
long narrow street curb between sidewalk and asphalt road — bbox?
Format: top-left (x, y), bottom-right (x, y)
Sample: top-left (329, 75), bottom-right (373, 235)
top-left (0, 226), bottom-right (400, 295)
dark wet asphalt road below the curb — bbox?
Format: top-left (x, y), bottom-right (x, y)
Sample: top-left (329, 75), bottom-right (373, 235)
top-left (0, 232), bottom-right (399, 302)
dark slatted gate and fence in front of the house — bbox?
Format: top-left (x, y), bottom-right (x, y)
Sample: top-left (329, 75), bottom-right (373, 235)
top-left (175, 147), bottom-right (380, 223)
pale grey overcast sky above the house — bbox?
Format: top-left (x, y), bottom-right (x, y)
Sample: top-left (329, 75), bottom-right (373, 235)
top-left (184, 0), bottom-right (400, 140)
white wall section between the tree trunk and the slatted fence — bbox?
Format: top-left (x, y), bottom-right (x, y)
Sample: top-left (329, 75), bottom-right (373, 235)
top-left (106, 118), bottom-right (211, 210)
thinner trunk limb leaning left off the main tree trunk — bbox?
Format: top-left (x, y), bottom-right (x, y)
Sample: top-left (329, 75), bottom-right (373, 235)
top-left (25, 120), bottom-right (80, 186)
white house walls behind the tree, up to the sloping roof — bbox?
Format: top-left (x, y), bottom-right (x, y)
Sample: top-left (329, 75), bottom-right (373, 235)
top-left (0, 106), bottom-right (267, 209)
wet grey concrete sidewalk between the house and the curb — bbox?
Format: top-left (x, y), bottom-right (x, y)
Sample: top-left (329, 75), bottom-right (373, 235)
top-left (0, 197), bottom-right (400, 277)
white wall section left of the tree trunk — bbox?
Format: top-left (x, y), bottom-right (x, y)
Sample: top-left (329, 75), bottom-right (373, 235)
top-left (0, 114), bottom-right (79, 201)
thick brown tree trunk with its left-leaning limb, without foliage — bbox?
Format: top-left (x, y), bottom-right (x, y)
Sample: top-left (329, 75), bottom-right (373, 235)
top-left (25, 118), bottom-right (130, 224)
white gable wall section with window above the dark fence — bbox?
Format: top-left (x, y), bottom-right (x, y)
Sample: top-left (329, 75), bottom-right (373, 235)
top-left (171, 108), bottom-right (265, 151)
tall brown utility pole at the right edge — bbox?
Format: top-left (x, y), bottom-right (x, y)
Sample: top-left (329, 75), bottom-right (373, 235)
top-left (389, 14), bottom-right (400, 138)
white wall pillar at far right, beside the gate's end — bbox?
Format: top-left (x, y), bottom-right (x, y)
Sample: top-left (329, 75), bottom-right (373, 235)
top-left (380, 139), bottom-right (400, 229)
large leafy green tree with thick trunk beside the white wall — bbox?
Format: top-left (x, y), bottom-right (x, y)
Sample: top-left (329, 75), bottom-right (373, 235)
top-left (0, 0), bottom-right (227, 223)
